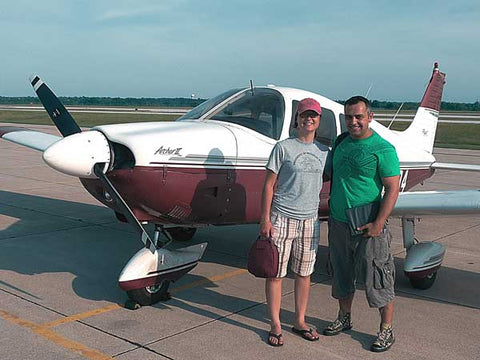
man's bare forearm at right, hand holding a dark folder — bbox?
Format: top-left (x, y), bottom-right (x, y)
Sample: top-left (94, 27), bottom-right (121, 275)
top-left (358, 175), bottom-right (400, 237)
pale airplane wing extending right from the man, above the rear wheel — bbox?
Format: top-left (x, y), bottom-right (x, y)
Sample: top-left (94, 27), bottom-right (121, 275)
top-left (392, 190), bottom-right (480, 216)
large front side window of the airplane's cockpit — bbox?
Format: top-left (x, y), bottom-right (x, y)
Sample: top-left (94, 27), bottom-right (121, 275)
top-left (206, 89), bottom-right (285, 140)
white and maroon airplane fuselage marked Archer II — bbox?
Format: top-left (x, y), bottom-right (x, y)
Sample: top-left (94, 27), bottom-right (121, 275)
top-left (62, 86), bottom-right (435, 226)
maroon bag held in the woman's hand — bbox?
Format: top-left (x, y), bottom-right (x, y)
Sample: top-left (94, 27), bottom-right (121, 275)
top-left (247, 235), bottom-right (278, 278)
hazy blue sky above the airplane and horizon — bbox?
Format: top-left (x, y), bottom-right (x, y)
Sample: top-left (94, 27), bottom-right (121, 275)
top-left (0, 0), bottom-right (480, 102)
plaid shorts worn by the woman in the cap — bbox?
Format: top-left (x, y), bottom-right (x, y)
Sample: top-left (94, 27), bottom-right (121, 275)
top-left (270, 211), bottom-right (320, 277)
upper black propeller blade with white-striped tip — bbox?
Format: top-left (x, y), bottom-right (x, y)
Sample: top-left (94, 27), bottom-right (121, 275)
top-left (30, 75), bottom-right (82, 136)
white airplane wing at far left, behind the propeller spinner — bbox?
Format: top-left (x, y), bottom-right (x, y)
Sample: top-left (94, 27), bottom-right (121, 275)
top-left (0, 126), bottom-right (62, 151)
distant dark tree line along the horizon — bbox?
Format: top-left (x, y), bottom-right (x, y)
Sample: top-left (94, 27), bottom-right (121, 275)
top-left (0, 96), bottom-right (480, 111)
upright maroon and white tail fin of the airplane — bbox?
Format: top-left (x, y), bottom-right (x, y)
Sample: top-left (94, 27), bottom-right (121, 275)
top-left (401, 63), bottom-right (445, 154)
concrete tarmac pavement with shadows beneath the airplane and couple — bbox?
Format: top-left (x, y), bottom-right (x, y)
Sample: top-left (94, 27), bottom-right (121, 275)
top-left (0, 124), bottom-right (480, 360)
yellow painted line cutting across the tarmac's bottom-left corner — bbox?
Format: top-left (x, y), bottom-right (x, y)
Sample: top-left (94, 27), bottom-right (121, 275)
top-left (0, 310), bottom-right (113, 360)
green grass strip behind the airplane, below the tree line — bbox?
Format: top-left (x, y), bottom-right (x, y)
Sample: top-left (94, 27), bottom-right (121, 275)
top-left (0, 110), bottom-right (480, 150)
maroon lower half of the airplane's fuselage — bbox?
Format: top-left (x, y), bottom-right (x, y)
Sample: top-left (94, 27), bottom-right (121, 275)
top-left (81, 164), bottom-right (433, 225)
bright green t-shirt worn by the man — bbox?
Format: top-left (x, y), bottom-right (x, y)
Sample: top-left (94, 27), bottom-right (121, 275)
top-left (327, 132), bottom-right (400, 222)
